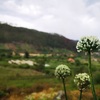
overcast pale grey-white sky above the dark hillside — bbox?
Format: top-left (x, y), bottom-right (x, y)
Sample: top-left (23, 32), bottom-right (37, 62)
top-left (0, 0), bottom-right (100, 40)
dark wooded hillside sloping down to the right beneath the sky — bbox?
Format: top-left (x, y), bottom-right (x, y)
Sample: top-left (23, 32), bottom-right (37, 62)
top-left (0, 23), bottom-right (76, 51)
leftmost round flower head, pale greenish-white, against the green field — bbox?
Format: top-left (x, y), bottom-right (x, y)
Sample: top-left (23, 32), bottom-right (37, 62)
top-left (55, 64), bottom-right (71, 79)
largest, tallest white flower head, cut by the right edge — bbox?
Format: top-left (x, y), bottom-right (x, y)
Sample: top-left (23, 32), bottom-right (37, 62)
top-left (76, 36), bottom-right (100, 52)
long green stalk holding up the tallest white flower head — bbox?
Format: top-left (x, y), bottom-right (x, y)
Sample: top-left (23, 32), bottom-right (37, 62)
top-left (88, 50), bottom-right (97, 100)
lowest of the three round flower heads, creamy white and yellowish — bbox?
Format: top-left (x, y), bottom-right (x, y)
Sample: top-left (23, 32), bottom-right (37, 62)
top-left (74, 73), bottom-right (90, 90)
